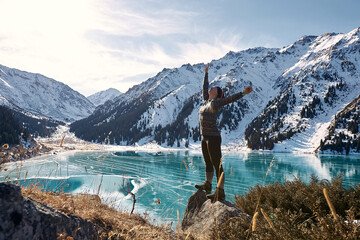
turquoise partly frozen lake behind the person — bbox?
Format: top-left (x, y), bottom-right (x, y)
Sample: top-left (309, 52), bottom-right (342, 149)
top-left (0, 151), bottom-right (360, 227)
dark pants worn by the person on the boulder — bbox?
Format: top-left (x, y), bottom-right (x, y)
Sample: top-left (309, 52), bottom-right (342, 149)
top-left (201, 136), bottom-right (224, 180)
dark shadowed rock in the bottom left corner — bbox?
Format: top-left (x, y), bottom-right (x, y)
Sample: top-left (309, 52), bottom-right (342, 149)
top-left (0, 183), bottom-right (98, 240)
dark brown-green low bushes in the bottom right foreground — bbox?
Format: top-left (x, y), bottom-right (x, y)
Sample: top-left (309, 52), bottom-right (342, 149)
top-left (213, 177), bottom-right (360, 240)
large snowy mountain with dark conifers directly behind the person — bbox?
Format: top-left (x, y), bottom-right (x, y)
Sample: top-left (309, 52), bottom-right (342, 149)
top-left (71, 28), bottom-right (360, 152)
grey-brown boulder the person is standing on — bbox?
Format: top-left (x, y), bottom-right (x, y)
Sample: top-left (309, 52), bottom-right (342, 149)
top-left (181, 190), bottom-right (250, 239)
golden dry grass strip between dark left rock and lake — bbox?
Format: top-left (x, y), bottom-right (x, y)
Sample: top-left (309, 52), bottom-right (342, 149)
top-left (22, 187), bottom-right (183, 240)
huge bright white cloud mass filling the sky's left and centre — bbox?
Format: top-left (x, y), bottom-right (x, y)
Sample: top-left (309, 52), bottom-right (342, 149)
top-left (0, 0), bottom-right (282, 95)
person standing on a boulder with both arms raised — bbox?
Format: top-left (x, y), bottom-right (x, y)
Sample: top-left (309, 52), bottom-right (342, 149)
top-left (195, 64), bottom-right (252, 202)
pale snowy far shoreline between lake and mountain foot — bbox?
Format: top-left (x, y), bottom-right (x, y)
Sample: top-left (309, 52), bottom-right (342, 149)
top-left (0, 123), bottom-right (360, 170)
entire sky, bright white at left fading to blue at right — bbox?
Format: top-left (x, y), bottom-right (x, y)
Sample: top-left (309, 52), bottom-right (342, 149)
top-left (0, 0), bottom-right (360, 96)
